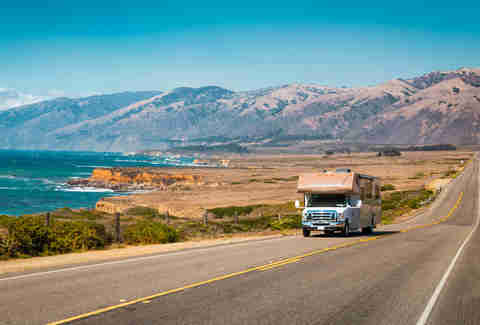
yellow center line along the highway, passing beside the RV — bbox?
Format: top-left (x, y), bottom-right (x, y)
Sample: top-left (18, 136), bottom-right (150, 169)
top-left (47, 192), bottom-right (463, 325)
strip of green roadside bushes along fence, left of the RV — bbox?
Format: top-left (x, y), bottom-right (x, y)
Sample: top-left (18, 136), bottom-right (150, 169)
top-left (0, 202), bottom-right (301, 260)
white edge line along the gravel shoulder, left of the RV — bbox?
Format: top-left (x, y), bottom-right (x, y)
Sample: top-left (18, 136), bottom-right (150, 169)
top-left (0, 236), bottom-right (291, 282)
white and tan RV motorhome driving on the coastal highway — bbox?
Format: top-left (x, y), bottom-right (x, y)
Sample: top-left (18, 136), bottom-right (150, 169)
top-left (295, 169), bottom-right (382, 237)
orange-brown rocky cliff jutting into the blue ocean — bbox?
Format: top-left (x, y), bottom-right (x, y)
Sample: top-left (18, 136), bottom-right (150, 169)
top-left (68, 167), bottom-right (203, 192)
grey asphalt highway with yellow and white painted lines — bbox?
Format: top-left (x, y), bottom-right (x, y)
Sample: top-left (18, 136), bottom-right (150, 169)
top-left (0, 156), bottom-right (480, 325)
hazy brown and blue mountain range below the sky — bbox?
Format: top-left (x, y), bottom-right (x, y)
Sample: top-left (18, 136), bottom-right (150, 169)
top-left (0, 68), bottom-right (480, 151)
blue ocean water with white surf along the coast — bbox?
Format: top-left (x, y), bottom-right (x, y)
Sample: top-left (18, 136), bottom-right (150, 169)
top-left (0, 150), bottom-right (192, 216)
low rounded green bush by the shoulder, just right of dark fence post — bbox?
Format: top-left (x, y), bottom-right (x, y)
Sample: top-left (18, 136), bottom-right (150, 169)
top-left (123, 220), bottom-right (179, 245)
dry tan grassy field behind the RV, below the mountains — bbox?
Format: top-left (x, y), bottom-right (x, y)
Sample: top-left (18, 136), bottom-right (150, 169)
top-left (101, 151), bottom-right (472, 218)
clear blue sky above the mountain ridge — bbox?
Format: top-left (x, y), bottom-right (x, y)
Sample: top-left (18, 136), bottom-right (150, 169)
top-left (0, 0), bottom-right (480, 98)
